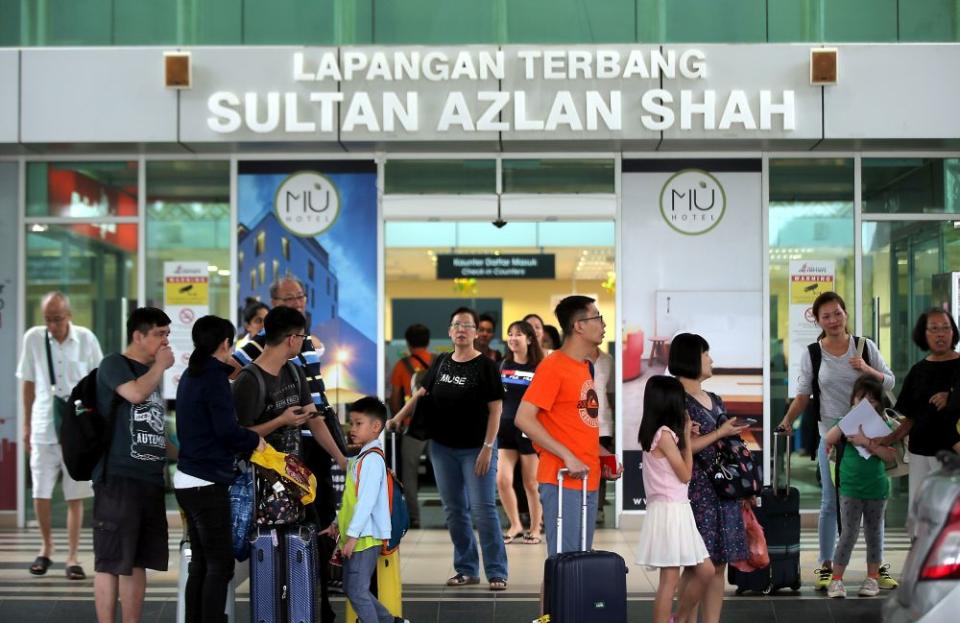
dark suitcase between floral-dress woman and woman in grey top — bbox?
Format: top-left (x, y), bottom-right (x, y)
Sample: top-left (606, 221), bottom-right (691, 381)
top-left (727, 430), bottom-right (800, 595)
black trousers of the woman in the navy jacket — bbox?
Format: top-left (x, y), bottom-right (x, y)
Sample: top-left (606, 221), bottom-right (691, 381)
top-left (176, 484), bottom-right (234, 623)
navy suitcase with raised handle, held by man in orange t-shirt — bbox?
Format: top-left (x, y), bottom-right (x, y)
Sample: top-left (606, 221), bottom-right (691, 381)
top-left (543, 469), bottom-right (627, 623)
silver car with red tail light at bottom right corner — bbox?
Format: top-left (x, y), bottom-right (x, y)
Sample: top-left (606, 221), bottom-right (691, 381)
top-left (883, 452), bottom-right (960, 623)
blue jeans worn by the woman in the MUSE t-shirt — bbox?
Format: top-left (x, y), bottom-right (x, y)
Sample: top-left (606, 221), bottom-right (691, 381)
top-left (430, 440), bottom-right (507, 580)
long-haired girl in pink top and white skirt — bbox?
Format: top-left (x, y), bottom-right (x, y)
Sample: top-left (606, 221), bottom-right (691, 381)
top-left (637, 376), bottom-right (713, 623)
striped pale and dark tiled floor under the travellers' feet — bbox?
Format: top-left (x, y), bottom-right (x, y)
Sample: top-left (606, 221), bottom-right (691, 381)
top-left (0, 529), bottom-right (908, 623)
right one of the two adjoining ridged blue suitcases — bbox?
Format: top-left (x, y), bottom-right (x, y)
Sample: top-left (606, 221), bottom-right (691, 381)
top-left (283, 524), bottom-right (320, 623)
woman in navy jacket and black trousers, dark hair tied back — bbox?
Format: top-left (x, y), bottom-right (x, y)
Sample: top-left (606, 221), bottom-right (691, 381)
top-left (173, 316), bottom-right (264, 621)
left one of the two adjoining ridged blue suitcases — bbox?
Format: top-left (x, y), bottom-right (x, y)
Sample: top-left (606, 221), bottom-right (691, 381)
top-left (250, 526), bottom-right (286, 623)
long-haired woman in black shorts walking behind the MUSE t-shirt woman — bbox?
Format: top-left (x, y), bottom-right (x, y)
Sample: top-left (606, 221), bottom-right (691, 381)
top-left (497, 320), bottom-right (543, 545)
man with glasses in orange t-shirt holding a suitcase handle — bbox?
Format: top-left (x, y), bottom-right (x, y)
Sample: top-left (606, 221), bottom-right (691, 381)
top-left (516, 296), bottom-right (621, 554)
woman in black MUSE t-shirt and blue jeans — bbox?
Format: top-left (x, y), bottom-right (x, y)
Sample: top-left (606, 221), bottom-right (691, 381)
top-left (388, 307), bottom-right (507, 591)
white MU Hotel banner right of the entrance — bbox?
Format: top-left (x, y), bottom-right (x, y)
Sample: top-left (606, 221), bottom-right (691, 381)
top-left (618, 159), bottom-right (765, 511)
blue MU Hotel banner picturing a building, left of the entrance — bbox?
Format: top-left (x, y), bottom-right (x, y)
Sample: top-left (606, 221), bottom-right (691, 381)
top-left (237, 161), bottom-right (377, 404)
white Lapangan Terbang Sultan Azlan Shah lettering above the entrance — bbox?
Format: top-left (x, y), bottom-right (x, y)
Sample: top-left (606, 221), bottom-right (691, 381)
top-left (206, 46), bottom-right (801, 140)
